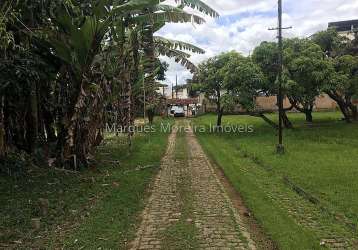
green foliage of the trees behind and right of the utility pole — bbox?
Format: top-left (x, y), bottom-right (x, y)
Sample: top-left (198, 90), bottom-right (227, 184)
top-left (252, 34), bottom-right (357, 121)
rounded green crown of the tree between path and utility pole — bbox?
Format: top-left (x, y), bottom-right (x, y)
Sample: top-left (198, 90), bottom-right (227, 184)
top-left (195, 51), bottom-right (266, 110)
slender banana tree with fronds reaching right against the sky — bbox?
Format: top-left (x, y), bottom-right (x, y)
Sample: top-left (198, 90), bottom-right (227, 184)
top-left (135, 0), bottom-right (218, 120)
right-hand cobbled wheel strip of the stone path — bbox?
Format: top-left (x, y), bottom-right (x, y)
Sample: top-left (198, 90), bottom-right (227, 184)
top-left (187, 127), bottom-right (255, 249)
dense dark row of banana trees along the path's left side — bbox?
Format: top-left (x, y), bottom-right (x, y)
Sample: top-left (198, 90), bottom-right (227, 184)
top-left (0, 0), bottom-right (218, 170)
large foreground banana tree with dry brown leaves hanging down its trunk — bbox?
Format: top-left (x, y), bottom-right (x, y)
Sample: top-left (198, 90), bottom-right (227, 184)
top-left (50, 0), bottom-right (156, 166)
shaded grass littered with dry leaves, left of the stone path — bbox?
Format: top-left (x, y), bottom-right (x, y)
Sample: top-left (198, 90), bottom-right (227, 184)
top-left (0, 120), bottom-right (172, 249)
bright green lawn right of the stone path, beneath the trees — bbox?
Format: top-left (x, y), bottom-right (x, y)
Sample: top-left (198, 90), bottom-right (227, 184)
top-left (194, 112), bottom-right (358, 249)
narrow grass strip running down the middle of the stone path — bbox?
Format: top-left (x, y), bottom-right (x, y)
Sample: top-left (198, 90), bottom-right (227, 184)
top-left (162, 125), bottom-right (198, 250)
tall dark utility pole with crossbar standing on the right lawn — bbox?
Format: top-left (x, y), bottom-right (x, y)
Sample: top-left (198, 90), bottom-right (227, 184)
top-left (269, 0), bottom-right (292, 154)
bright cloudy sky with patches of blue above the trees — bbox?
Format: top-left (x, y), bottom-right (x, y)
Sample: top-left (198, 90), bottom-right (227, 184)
top-left (157, 0), bottom-right (358, 88)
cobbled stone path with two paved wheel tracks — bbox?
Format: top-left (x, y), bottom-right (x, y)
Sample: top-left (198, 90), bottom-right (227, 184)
top-left (131, 123), bottom-right (256, 250)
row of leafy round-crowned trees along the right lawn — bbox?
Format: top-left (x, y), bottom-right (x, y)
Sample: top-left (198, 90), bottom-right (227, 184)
top-left (192, 29), bottom-right (358, 128)
